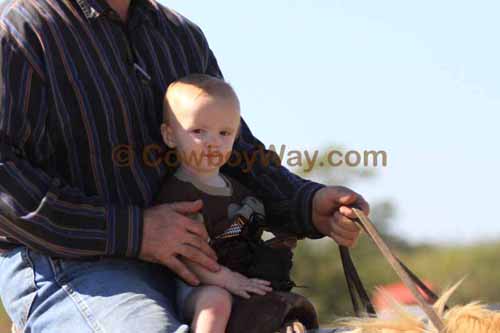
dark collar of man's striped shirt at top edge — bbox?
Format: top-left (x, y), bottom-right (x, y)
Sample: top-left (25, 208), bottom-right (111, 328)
top-left (76, 0), bottom-right (160, 24)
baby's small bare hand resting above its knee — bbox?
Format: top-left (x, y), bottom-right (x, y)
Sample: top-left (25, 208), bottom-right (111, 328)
top-left (222, 267), bottom-right (273, 298)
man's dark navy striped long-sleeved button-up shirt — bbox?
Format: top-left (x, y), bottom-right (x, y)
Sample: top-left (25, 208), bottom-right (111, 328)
top-left (0, 0), bottom-right (322, 259)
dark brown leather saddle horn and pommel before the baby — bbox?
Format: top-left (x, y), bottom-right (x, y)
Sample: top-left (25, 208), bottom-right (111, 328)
top-left (213, 228), bottom-right (319, 333)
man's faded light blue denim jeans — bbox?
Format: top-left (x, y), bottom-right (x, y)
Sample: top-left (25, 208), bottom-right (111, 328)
top-left (0, 246), bottom-right (189, 333)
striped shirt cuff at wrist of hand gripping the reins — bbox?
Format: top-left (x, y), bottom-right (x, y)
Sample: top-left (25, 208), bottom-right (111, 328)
top-left (292, 181), bottom-right (325, 239)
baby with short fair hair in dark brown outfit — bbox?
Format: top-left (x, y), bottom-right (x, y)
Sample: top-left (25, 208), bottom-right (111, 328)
top-left (156, 74), bottom-right (292, 333)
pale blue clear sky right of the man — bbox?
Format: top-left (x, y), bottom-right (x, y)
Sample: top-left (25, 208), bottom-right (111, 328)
top-left (160, 0), bottom-right (500, 243)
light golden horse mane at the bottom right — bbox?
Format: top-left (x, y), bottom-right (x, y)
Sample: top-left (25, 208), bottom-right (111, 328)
top-left (339, 281), bottom-right (500, 333)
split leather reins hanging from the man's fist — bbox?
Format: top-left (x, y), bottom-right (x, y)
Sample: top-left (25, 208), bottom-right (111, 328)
top-left (339, 208), bottom-right (444, 332)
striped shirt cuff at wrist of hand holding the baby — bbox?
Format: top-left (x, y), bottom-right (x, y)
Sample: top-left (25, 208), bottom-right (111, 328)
top-left (106, 205), bottom-right (144, 258)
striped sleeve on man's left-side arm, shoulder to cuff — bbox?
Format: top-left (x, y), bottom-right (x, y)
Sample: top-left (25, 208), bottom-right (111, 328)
top-left (0, 29), bottom-right (143, 257)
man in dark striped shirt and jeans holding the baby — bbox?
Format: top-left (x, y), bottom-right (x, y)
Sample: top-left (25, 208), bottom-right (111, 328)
top-left (0, 0), bottom-right (368, 332)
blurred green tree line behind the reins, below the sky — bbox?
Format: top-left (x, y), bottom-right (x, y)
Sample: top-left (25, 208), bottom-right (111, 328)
top-left (293, 147), bottom-right (500, 323)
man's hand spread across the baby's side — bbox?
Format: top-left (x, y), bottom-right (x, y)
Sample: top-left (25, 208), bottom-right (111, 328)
top-left (139, 200), bottom-right (220, 285)
